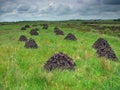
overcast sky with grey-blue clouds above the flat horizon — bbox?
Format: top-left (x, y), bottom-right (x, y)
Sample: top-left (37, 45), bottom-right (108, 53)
top-left (0, 0), bottom-right (120, 22)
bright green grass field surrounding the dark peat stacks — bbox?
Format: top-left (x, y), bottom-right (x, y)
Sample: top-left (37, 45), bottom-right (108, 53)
top-left (0, 21), bottom-right (120, 90)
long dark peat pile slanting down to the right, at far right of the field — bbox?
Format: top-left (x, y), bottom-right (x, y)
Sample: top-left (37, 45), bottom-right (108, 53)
top-left (93, 38), bottom-right (117, 60)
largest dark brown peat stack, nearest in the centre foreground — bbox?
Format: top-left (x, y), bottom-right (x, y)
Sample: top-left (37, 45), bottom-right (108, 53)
top-left (44, 52), bottom-right (76, 71)
